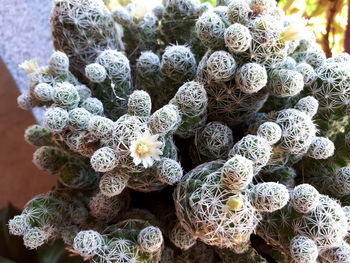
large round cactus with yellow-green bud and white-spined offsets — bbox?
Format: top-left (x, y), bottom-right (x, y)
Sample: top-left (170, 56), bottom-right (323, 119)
top-left (174, 121), bottom-right (289, 249)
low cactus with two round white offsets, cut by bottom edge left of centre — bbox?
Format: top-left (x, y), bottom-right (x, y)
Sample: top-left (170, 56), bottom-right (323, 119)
top-left (73, 219), bottom-right (163, 263)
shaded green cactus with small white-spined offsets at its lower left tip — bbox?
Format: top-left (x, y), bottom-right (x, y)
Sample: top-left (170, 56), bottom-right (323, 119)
top-left (8, 190), bottom-right (89, 249)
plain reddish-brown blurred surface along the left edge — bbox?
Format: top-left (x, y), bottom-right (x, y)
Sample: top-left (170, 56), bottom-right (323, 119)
top-left (0, 59), bottom-right (56, 208)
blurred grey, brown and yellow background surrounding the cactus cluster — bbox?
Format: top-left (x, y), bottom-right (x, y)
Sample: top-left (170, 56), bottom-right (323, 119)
top-left (0, 0), bottom-right (350, 208)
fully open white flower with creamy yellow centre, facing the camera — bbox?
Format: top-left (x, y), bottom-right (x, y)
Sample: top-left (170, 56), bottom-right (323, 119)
top-left (130, 131), bottom-right (163, 168)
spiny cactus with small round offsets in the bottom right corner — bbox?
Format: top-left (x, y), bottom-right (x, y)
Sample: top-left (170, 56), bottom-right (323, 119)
top-left (258, 184), bottom-right (349, 262)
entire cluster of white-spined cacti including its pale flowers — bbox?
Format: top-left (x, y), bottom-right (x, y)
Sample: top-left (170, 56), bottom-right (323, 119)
top-left (8, 0), bottom-right (350, 263)
